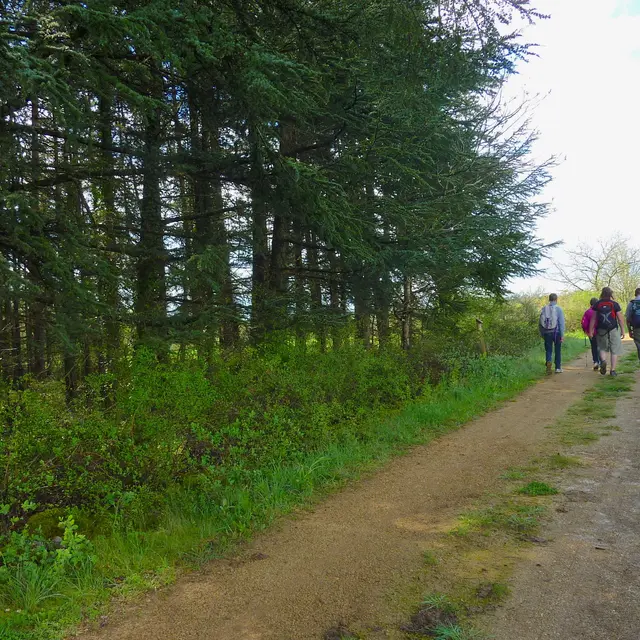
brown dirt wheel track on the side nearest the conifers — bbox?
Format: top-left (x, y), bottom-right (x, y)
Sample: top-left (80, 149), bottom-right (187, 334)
top-left (83, 358), bottom-right (608, 640)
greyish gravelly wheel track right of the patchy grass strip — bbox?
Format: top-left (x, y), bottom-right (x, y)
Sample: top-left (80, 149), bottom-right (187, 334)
top-left (483, 364), bottom-right (640, 640)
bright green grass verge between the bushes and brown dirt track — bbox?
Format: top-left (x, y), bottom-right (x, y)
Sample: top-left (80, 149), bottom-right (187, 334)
top-left (0, 338), bottom-right (584, 640)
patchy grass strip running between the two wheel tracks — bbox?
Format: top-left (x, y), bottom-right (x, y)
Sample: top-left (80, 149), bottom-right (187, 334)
top-left (384, 354), bottom-right (638, 640)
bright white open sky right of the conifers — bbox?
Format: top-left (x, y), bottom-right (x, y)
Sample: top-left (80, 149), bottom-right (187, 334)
top-left (506, 0), bottom-right (640, 291)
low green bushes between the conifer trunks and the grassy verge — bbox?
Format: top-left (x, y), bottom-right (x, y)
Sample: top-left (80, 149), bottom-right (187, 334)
top-left (0, 301), bottom-right (560, 537)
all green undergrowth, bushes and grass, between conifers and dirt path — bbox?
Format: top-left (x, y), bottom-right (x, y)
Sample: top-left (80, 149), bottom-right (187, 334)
top-left (0, 339), bottom-right (583, 640)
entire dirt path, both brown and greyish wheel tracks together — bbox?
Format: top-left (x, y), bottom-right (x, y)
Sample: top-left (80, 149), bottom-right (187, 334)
top-left (79, 343), bottom-right (640, 640)
